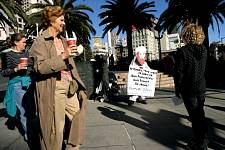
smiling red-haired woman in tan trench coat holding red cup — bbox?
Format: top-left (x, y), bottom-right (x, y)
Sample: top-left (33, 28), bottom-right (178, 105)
top-left (30, 6), bottom-right (87, 150)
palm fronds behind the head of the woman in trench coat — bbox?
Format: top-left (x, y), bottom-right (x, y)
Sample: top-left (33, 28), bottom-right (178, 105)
top-left (27, 0), bottom-right (96, 43)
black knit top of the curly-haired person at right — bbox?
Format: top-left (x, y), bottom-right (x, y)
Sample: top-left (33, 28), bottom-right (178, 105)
top-left (174, 44), bottom-right (207, 96)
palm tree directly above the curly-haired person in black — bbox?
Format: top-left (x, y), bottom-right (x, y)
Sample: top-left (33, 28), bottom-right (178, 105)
top-left (157, 0), bottom-right (225, 47)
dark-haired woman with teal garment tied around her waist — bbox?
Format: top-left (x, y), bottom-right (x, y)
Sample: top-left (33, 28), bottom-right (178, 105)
top-left (1, 33), bottom-right (32, 140)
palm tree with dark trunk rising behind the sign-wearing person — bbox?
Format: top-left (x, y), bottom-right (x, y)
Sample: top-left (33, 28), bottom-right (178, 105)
top-left (99, 0), bottom-right (155, 61)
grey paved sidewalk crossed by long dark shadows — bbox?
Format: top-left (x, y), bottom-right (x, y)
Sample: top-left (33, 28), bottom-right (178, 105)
top-left (0, 89), bottom-right (225, 150)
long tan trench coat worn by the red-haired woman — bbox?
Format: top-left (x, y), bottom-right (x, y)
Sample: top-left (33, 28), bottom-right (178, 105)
top-left (30, 30), bottom-right (87, 150)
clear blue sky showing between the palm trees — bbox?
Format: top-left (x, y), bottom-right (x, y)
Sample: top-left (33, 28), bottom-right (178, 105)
top-left (76, 0), bottom-right (225, 43)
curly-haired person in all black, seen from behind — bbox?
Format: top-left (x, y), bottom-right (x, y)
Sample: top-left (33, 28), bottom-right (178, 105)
top-left (174, 24), bottom-right (208, 150)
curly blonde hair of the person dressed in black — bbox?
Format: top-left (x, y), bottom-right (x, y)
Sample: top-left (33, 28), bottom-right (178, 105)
top-left (181, 23), bottom-right (205, 45)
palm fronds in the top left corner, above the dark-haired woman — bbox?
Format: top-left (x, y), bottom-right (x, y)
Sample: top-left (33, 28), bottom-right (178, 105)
top-left (0, 0), bottom-right (27, 30)
